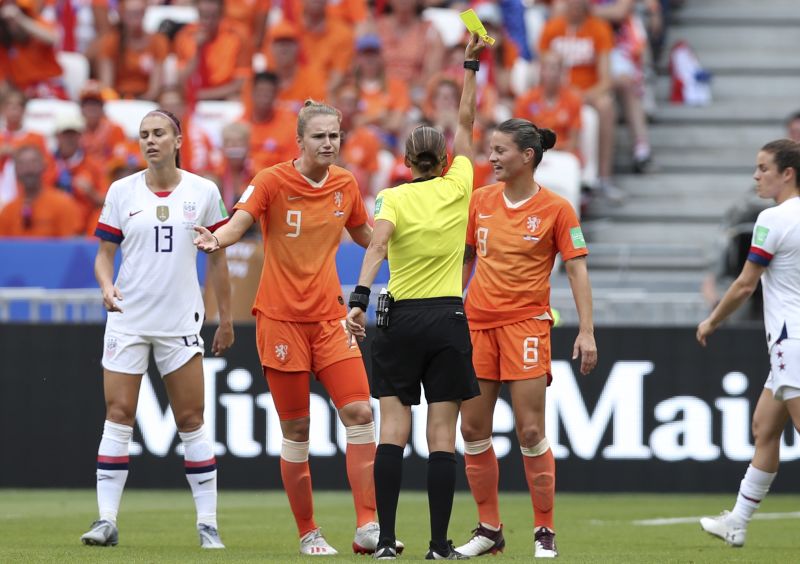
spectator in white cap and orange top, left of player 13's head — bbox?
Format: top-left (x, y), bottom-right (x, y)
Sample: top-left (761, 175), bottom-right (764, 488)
top-left (49, 114), bottom-right (108, 231)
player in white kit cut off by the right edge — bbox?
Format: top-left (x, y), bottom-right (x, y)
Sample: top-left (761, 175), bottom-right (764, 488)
top-left (697, 139), bottom-right (800, 546)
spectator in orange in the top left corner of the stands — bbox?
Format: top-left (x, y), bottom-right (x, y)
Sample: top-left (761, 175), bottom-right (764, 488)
top-left (0, 0), bottom-right (67, 98)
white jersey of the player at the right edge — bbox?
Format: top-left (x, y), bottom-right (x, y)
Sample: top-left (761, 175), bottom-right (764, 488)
top-left (747, 197), bottom-right (800, 348)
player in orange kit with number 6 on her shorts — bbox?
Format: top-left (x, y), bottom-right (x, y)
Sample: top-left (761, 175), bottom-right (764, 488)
top-left (456, 119), bottom-right (597, 557)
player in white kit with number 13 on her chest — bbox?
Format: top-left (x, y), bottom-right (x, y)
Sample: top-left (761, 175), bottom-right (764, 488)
top-left (81, 110), bottom-right (233, 548)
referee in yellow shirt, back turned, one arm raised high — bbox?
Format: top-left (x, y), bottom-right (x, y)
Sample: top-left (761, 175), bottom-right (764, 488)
top-left (347, 35), bottom-right (485, 560)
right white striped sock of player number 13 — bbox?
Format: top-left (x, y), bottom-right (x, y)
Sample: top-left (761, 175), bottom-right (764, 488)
top-left (178, 425), bottom-right (217, 528)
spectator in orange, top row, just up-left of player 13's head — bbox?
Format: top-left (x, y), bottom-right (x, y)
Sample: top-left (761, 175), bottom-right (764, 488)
top-left (97, 0), bottom-right (169, 100)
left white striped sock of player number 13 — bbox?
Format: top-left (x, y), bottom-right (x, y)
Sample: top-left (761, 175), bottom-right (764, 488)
top-left (97, 421), bottom-right (133, 524)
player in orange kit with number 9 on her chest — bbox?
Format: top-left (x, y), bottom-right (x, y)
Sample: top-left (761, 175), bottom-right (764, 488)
top-left (195, 100), bottom-right (396, 556)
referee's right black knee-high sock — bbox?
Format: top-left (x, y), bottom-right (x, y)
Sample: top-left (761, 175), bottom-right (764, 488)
top-left (428, 451), bottom-right (456, 554)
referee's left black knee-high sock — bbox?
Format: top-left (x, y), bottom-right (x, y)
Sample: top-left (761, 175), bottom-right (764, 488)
top-left (374, 444), bottom-right (404, 546)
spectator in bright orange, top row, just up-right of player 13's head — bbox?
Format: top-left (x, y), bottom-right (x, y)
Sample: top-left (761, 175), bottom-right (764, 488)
top-left (174, 0), bottom-right (250, 101)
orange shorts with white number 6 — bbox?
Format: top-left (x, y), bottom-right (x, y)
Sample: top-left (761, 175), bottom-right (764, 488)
top-left (469, 319), bottom-right (552, 384)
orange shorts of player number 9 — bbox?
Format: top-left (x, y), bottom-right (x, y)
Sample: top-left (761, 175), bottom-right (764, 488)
top-left (256, 313), bottom-right (361, 374)
